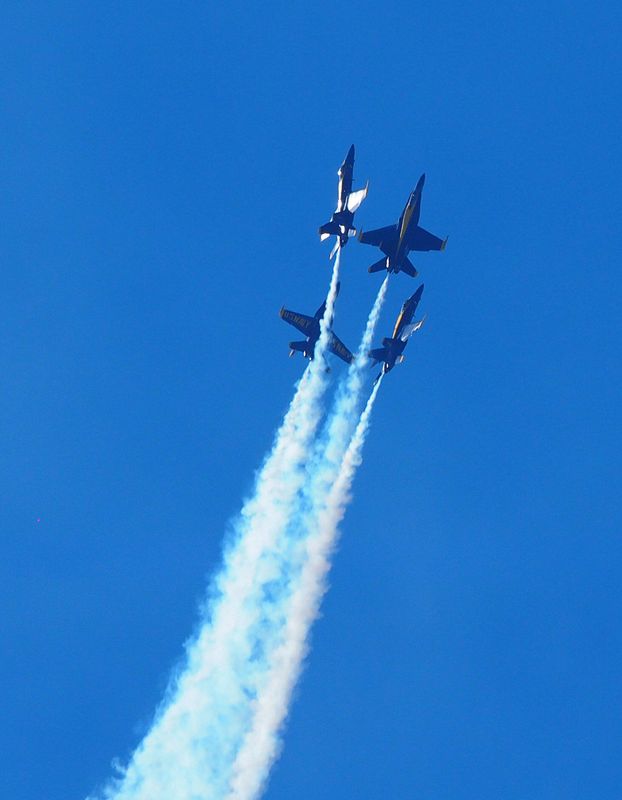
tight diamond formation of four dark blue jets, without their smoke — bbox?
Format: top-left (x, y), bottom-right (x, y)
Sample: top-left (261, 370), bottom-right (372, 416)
top-left (280, 145), bottom-right (447, 381)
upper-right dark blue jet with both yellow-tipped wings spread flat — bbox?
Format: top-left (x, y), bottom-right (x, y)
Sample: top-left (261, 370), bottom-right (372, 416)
top-left (359, 175), bottom-right (447, 278)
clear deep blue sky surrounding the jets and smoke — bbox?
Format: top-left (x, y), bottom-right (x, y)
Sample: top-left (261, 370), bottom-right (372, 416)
top-left (0, 0), bottom-right (622, 800)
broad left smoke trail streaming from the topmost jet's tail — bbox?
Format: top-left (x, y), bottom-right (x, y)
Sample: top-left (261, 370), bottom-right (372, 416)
top-left (92, 252), bottom-right (340, 800)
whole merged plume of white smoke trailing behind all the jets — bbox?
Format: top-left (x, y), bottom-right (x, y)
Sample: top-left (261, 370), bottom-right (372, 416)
top-left (92, 250), bottom-right (388, 800)
